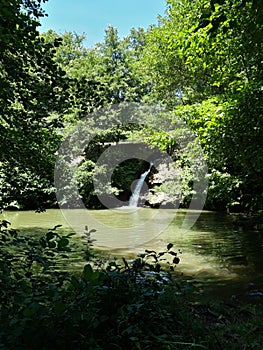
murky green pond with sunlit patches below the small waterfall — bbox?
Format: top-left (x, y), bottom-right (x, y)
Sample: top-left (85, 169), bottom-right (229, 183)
top-left (0, 208), bottom-right (263, 300)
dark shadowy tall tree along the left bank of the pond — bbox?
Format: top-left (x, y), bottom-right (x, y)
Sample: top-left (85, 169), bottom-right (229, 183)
top-left (0, 0), bottom-right (64, 206)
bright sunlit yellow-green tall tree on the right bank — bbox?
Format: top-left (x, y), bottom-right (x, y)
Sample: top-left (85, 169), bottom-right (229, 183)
top-left (144, 0), bottom-right (263, 210)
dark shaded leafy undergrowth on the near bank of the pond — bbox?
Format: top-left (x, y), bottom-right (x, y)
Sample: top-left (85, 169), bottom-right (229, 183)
top-left (0, 221), bottom-right (263, 350)
